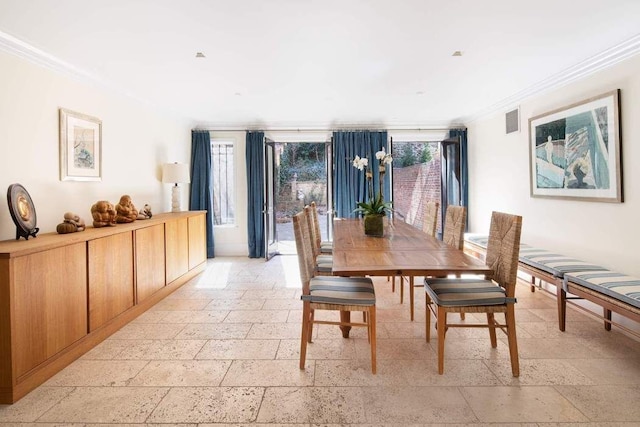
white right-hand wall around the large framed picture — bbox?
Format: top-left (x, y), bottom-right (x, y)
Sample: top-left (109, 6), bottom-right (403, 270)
top-left (468, 56), bottom-right (640, 275)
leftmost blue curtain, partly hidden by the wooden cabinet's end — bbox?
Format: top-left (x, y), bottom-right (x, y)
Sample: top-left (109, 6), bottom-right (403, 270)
top-left (189, 130), bottom-right (215, 258)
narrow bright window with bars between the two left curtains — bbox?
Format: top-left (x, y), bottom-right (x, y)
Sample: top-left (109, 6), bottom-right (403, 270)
top-left (211, 140), bottom-right (236, 225)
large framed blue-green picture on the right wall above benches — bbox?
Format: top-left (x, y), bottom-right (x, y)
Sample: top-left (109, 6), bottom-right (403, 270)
top-left (529, 89), bottom-right (623, 203)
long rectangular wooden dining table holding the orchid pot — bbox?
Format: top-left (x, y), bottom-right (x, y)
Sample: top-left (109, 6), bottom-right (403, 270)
top-left (332, 218), bottom-right (492, 337)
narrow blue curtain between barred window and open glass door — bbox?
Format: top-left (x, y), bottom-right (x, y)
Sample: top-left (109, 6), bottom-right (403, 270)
top-left (246, 132), bottom-right (264, 258)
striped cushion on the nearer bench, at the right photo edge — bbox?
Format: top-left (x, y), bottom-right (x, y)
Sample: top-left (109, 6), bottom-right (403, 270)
top-left (564, 270), bottom-right (640, 308)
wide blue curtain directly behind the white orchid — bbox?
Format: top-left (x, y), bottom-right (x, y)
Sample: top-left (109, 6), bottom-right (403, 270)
top-left (333, 131), bottom-right (391, 218)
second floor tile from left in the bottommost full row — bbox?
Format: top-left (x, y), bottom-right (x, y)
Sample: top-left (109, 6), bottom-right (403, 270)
top-left (38, 387), bottom-right (169, 423)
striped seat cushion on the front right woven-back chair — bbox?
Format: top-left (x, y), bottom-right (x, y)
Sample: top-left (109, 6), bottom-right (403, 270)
top-left (424, 278), bottom-right (515, 307)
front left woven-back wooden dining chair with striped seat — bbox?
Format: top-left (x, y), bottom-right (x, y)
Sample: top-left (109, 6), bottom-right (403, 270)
top-left (293, 212), bottom-right (376, 374)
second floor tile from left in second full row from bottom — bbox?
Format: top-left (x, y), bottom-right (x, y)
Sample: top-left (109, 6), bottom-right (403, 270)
top-left (129, 360), bottom-right (231, 387)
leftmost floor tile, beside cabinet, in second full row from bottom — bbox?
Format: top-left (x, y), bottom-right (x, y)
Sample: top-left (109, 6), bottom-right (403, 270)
top-left (45, 360), bottom-right (147, 387)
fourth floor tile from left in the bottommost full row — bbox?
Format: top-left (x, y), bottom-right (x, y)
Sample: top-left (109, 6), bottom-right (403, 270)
top-left (257, 387), bottom-right (369, 425)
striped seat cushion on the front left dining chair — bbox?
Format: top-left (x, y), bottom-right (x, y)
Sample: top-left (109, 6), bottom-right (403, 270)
top-left (301, 276), bottom-right (376, 306)
